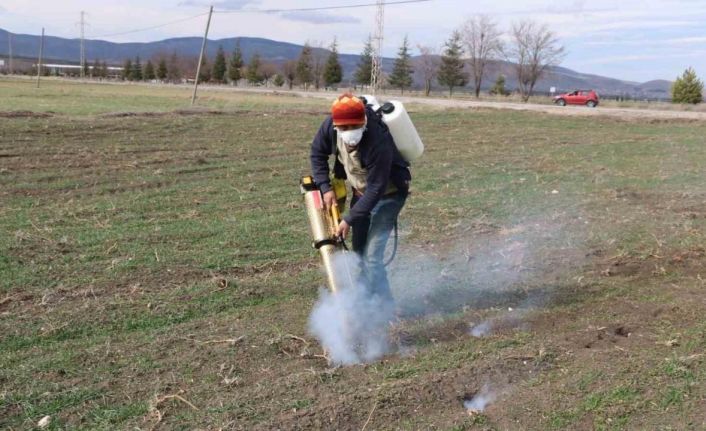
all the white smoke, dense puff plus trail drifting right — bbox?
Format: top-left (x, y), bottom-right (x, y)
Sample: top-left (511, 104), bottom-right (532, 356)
top-left (309, 216), bottom-right (585, 365)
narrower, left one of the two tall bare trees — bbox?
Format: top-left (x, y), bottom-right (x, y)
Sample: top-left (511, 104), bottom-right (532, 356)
top-left (461, 15), bottom-right (502, 97)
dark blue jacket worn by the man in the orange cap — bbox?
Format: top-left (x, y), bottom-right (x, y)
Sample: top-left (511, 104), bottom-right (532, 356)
top-left (311, 108), bottom-right (412, 224)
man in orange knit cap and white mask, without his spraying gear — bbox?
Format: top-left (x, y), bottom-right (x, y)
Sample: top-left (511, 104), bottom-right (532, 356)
top-left (311, 93), bottom-right (411, 301)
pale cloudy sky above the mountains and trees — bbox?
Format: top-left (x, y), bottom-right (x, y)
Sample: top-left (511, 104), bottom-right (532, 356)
top-left (0, 0), bottom-right (706, 81)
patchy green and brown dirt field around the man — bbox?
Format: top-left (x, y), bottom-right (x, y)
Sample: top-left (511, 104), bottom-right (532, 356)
top-left (0, 80), bottom-right (706, 430)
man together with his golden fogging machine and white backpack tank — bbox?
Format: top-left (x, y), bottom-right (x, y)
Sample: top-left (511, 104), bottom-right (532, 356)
top-left (302, 93), bottom-right (423, 364)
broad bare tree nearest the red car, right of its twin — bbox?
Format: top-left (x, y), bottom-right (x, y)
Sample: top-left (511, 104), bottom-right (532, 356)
top-left (507, 21), bottom-right (565, 102)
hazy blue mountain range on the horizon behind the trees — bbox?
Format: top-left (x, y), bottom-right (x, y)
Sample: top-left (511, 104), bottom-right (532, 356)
top-left (0, 29), bottom-right (671, 99)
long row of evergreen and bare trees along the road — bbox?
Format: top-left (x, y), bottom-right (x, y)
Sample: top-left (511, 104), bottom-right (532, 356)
top-left (106, 15), bottom-right (564, 100)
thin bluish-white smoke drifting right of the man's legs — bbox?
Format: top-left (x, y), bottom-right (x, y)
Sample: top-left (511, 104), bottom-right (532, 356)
top-left (390, 216), bottom-right (586, 320)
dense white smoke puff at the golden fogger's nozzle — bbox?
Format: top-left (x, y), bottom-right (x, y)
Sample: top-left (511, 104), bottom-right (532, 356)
top-left (309, 253), bottom-right (394, 365)
